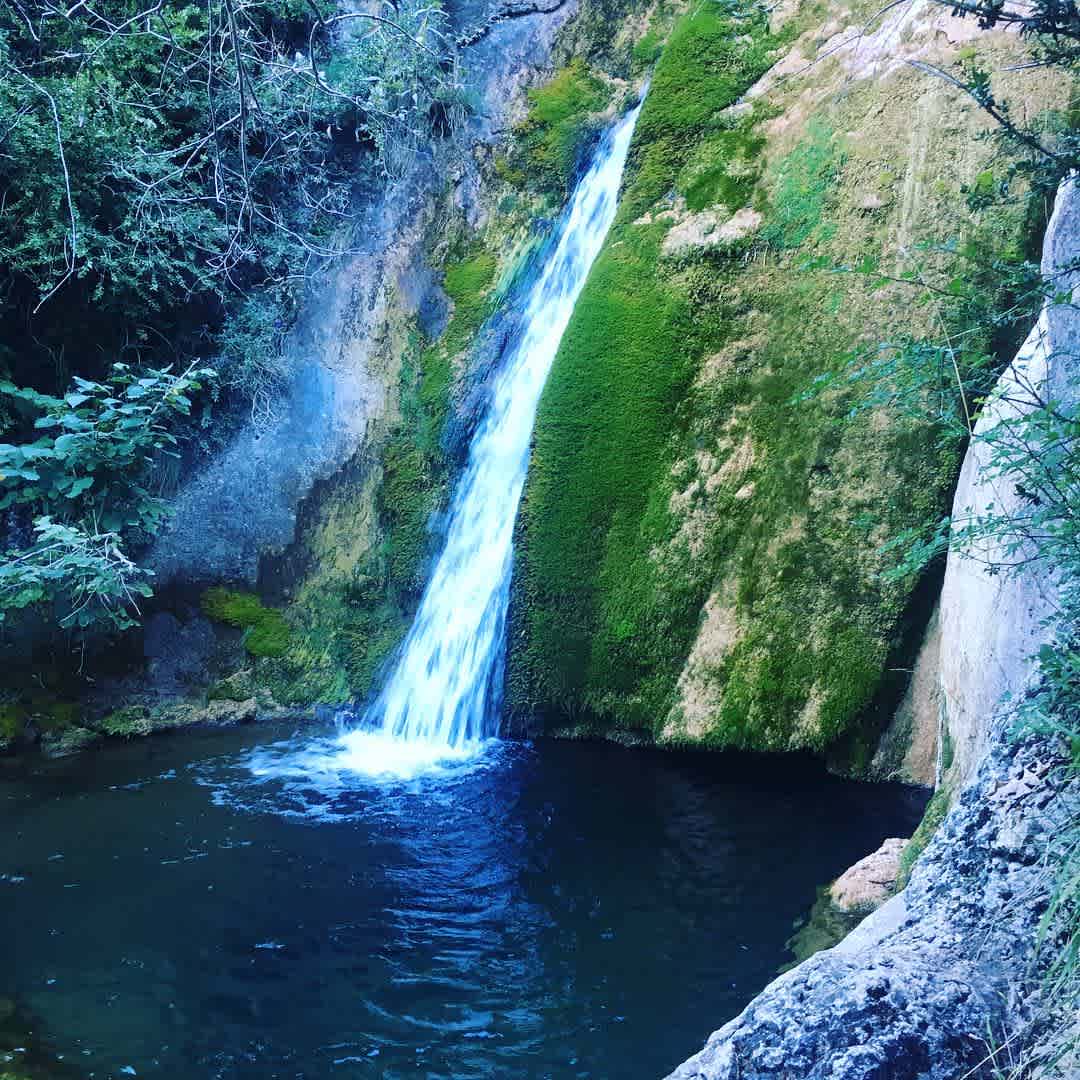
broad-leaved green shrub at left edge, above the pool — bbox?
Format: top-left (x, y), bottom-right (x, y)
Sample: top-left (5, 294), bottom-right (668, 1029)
top-left (0, 364), bottom-right (214, 630)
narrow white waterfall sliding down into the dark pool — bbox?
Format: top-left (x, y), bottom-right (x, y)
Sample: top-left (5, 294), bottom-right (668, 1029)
top-left (339, 106), bottom-right (640, 772)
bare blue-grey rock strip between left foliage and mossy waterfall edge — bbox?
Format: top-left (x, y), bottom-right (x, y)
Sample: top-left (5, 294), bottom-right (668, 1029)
top-left (147, 0), bottom-right (578, 586)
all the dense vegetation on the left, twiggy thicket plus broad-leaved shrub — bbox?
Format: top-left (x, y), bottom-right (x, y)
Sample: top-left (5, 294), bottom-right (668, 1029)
top-left (0, 0), bottom-right (459, 626)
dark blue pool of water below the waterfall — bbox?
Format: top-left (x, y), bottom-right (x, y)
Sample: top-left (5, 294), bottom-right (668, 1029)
top-left (0, 728), bottom-right (922, 1080)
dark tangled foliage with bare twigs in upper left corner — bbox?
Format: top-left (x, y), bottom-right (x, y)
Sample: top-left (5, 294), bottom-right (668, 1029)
top-left (0, 0), bottom-right (456, 399)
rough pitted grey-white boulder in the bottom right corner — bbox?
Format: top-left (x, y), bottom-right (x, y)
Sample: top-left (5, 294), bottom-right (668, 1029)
top-left (672, 730), bottom-right (1080, 1080)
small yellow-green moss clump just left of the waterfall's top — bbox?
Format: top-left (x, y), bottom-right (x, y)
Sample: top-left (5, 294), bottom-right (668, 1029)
top-left (515, 59), bottom-right (611, 199)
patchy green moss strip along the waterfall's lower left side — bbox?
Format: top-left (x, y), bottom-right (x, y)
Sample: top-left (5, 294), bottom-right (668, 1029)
top-left (261, 243), bottom-right (499, 704)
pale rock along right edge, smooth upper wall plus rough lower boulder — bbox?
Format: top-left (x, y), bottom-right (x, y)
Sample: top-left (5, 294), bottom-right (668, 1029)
top-left (672, 183), bottom-right (1080, 1080)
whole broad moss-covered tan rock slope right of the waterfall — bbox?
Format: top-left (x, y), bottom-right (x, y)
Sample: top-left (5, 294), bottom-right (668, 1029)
top-left (509, 5), bottom-right (1065, 751)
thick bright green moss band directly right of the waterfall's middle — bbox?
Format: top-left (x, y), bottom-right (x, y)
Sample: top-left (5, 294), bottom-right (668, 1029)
top-left (511, 227), bottom-right (702, 723)
